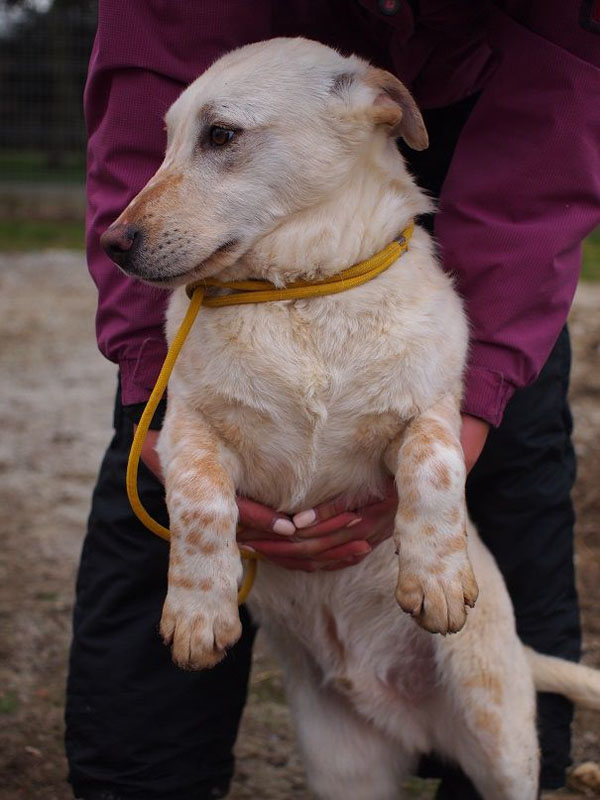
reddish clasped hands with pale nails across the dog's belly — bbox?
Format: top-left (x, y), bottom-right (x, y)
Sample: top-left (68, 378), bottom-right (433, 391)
top-left (238, 479), bottom-right (398, 572)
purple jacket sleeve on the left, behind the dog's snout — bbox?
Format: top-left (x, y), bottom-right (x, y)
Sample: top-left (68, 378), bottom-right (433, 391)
top-left (84, 0), bottom-right (271, 404)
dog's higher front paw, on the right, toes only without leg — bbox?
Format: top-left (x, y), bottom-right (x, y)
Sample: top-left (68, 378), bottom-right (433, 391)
top-left (396, 553), bottom-right (479, 635)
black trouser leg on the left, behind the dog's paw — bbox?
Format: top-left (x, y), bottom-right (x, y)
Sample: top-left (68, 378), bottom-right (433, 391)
top-left (65, 401), bottom-right (254, 800)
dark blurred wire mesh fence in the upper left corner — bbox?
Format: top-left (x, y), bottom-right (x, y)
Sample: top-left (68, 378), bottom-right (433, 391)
top-left (0, 0), bottom-right (96, 184)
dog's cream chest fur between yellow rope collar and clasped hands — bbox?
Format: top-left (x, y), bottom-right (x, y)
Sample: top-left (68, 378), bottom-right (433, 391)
top-left (167, 234), bottom-right (466, 512)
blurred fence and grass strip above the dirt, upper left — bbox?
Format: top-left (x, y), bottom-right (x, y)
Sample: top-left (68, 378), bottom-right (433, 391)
top-left (0, 0), bottom-right (96, 239)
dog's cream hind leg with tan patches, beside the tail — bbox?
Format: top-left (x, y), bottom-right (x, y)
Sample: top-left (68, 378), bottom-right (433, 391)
top-left (434, 562), bottom-right (539, 800)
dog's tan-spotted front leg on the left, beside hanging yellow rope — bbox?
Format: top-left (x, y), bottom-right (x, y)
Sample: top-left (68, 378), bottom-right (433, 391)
top-left (158, 399), bottom-right (242, 669)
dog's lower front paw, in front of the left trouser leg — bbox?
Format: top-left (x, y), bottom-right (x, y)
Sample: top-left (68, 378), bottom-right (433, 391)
top-left (160, 589), bottom-right (242, 669)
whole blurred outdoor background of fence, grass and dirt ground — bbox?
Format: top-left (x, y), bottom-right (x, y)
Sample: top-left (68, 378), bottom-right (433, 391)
top-left (0, 0), bottom-right (600, 800)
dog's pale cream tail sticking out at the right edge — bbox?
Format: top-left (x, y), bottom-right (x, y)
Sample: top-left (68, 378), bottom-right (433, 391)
top-left (525, 647), bottom-right (600, 711)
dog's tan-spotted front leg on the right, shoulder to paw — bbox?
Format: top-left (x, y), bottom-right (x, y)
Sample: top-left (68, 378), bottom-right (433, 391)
top-left (386, 395), bottom-right (478, 634)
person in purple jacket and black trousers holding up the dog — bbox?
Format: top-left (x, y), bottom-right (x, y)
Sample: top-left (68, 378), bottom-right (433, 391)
top-left (66, 0), bottom-right (600, 800)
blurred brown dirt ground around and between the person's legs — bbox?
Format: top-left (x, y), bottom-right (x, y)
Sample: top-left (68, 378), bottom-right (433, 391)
top-left (0, 252), bottom-right (600, 800)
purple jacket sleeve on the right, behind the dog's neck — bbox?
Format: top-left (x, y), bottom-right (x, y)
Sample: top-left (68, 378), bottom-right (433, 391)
top-left (436, 3), bottom-right (600, 425)
